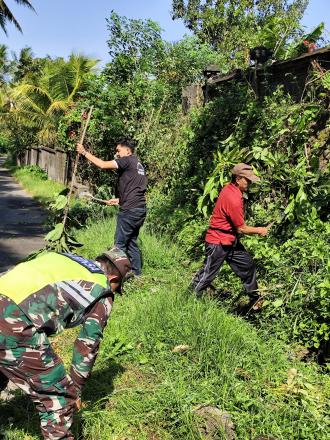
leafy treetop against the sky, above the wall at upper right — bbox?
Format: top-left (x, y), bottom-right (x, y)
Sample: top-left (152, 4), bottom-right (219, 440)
top-left (172, 0), bottom-right (308, 66)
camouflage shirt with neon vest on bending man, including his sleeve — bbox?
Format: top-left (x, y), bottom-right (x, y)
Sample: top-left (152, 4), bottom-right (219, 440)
top-left (0, 253), bottom-right (113, 389)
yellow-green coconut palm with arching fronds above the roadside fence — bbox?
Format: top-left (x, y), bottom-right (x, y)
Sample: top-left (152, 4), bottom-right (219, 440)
top-left (10, 54), bottom-right (98, 145)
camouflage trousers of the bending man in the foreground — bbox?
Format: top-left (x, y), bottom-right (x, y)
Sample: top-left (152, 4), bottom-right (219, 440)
top-left (0, 295), bottom-right (78, 440)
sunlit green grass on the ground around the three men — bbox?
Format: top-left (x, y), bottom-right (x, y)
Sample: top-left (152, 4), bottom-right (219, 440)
top-left (0, 181), bottom-right (330, 440)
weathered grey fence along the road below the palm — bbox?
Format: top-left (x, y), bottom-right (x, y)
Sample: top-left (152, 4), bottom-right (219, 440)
top-left (17, 146), bottom-right (71, 185)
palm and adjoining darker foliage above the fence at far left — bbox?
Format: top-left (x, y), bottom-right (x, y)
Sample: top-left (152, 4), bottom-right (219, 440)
top-left (3, 49), bottom-right (97, 148)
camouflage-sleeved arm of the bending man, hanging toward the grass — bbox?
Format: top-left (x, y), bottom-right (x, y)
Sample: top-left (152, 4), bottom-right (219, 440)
top-left (70, 297), bottom-right (112, 393)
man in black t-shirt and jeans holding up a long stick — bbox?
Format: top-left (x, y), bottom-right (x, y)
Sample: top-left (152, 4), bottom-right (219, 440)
top-left (77, 139), bottom-right (147, 275)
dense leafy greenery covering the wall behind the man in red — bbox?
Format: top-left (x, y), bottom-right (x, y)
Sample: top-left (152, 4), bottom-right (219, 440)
top-left (143, 84), bottom-right (330, 352)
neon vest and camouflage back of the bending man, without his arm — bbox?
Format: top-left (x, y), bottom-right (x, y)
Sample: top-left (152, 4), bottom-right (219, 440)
top-left (0, 252), bottom-right (111, 335)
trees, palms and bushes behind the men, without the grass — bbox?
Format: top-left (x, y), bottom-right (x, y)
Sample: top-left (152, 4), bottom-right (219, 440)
top-left (1, 7), bottom-right (330, 359)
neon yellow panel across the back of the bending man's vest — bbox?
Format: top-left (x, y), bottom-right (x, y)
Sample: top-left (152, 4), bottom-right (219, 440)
top-left (0, 252), bottom-right (107, 304)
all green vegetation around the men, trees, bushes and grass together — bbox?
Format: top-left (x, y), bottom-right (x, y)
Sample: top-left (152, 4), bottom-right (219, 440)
top-left (0, 0), bottom-right (330, 440)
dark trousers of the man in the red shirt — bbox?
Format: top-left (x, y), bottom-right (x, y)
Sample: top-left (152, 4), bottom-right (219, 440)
top-left (192, 241), bottom-right (258, 297)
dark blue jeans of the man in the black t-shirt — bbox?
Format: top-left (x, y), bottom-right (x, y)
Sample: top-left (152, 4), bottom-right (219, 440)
top-left (115, 208), bottom-right (146, 275)
